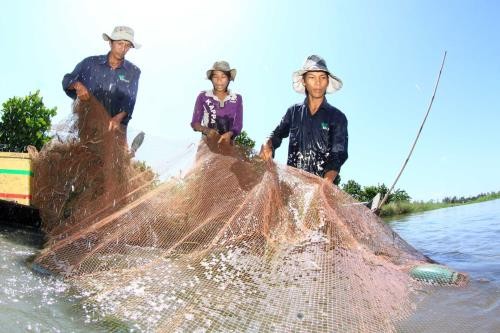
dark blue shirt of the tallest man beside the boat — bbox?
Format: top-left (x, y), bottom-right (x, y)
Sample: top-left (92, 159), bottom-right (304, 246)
top-left (62, 55), bottom-right (141, 125)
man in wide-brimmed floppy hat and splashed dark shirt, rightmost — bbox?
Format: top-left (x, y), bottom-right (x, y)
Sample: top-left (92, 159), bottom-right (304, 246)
top-left (260, 55), bottom-right (348, 182)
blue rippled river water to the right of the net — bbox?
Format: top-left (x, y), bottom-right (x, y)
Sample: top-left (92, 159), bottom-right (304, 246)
top-left (390, 200), bottom-right (500, 332)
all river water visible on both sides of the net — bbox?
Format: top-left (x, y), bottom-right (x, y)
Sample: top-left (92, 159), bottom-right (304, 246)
top-left (0, 200), bottom-right (500, 333)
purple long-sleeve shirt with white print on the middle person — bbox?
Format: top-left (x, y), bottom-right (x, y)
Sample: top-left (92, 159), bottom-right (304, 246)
top-left (191, 90), bottom-right (243, 137)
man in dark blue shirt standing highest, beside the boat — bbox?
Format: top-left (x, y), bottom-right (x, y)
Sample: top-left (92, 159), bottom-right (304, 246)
top-left (62, 26), bottom-right (141, 132)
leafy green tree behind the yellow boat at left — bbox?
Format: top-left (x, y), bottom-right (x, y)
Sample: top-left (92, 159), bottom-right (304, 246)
top-left (0, 90), bottom-right (57, 152)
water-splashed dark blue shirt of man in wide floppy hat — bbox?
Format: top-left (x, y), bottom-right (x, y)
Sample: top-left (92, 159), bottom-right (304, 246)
top-left (270, 98), bottom-right (348, 177)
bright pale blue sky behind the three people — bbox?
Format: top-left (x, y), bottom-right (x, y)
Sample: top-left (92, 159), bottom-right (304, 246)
top-left (0, 0), bottom-right (500, 201)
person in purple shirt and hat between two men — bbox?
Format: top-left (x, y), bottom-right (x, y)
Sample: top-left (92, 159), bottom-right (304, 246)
top-left (191, 61), bottom-right (243, 144)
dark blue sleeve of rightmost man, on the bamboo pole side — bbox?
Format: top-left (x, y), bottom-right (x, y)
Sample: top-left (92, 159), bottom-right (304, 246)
top-left (324, 114), bottom-right (349, 172)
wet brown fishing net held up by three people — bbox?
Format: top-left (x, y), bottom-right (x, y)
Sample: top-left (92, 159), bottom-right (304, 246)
top-left (32, 95), bottom-right (464, 333)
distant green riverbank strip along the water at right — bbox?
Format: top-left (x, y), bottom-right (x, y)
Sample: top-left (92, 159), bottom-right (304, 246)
top-left (380, 192), bottom-right (500, 218)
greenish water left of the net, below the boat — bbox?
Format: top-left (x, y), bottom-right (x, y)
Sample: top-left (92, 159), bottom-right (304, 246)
top-left (0, 228), bottom-right (103, 333)
